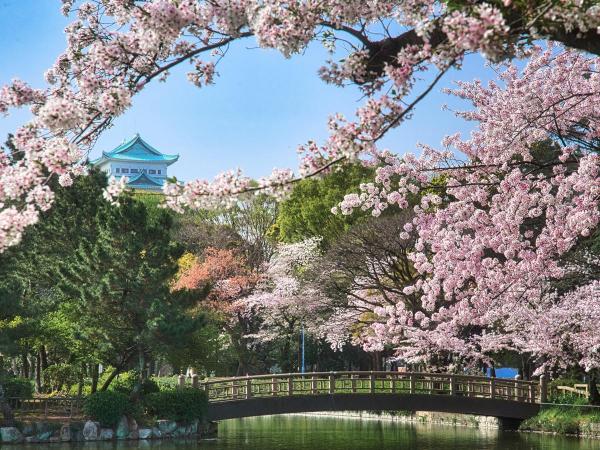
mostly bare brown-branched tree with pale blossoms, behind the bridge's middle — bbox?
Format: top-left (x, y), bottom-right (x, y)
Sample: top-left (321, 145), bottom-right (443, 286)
top-left (304, 211), bottom-right (421, 353)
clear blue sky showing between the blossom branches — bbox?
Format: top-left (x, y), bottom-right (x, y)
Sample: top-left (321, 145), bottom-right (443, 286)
top-left (0, 0), bottom-right (493, 180)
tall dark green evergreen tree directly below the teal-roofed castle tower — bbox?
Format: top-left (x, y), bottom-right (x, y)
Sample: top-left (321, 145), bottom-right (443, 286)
top-left (58, 190), bottom-right (202, 389)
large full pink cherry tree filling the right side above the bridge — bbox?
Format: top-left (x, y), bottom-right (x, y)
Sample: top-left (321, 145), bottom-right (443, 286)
top-left (340, 46), bottom-right (600, 367)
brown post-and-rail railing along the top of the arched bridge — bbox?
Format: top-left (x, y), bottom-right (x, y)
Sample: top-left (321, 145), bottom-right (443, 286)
top-left (200, 372), bottom-right (545, 403)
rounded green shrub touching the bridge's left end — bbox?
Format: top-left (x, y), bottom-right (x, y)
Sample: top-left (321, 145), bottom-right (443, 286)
top-left (144, 388), bottom-right (208, 423)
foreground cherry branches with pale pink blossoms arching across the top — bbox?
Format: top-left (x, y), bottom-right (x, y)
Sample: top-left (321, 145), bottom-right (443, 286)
top-left (0, 0), bottom-right (600, 250)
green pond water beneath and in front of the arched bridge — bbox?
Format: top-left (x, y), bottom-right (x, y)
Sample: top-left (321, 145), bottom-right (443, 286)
top-left (13, 416), bottom-right (600, 450)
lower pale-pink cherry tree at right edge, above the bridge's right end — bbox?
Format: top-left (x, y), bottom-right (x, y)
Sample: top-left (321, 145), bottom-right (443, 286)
top-left (495, 243), bottom-right (600, 398)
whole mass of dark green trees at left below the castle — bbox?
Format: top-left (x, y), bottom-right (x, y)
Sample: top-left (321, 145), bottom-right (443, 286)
top-left (0, 166), bottom-right (209, 400)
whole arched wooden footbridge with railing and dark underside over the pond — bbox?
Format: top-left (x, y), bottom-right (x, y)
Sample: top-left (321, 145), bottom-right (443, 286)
top-left (199, 372), bottom-right (547, 427)
